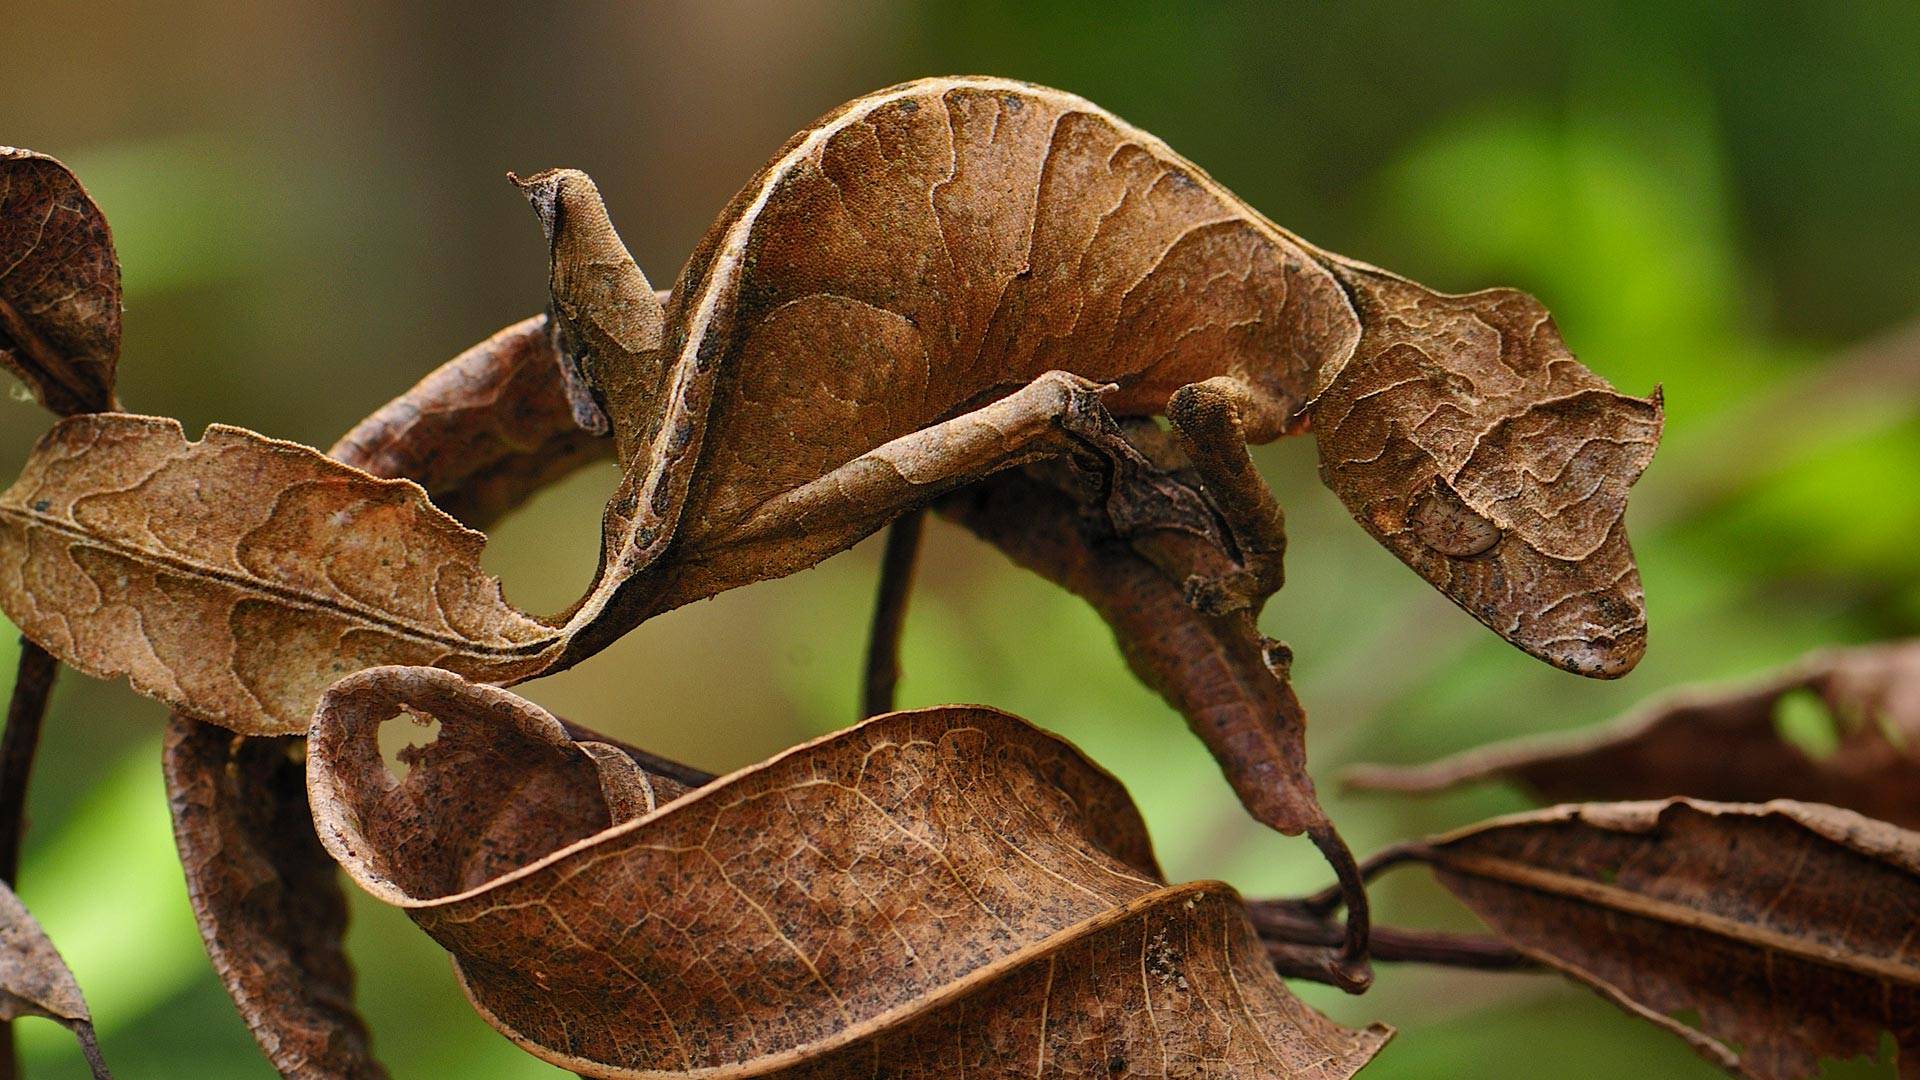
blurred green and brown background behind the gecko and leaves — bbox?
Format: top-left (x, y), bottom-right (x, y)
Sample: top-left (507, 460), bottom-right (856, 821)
top-left (0, 0), bottom-right (1920, 1080)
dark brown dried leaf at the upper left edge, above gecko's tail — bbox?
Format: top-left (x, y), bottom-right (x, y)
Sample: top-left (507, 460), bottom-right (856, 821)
top-left (0, 146), bottom-right (121, 415)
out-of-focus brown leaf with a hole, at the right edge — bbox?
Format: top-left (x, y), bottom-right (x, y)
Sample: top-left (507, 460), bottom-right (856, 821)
top-left (1344, 642), bottom-right (1920, 828)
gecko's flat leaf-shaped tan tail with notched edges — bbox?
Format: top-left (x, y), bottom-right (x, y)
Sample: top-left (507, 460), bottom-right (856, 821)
top-left (0, 413), bottom-right (555, 734)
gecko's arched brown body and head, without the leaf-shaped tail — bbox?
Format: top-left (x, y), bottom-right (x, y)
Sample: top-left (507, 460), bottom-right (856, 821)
top-left (522, 77), bottom-right (1661, 676)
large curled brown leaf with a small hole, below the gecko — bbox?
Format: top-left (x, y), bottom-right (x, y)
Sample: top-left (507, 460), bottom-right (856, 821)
top-left (309, 669), bottom-right (1388, 1078)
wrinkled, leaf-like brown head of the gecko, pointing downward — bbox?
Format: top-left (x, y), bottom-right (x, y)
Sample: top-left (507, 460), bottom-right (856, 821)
top-left (1308, 265), bottom-right (1661, 678)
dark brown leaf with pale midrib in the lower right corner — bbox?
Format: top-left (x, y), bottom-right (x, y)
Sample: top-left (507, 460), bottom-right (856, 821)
top-left (1404, 799), bottom-right (1920, 1080)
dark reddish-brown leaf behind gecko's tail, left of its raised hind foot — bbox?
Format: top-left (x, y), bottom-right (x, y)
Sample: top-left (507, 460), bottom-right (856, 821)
top-left (328, 315), bottom-right (612, 528)
